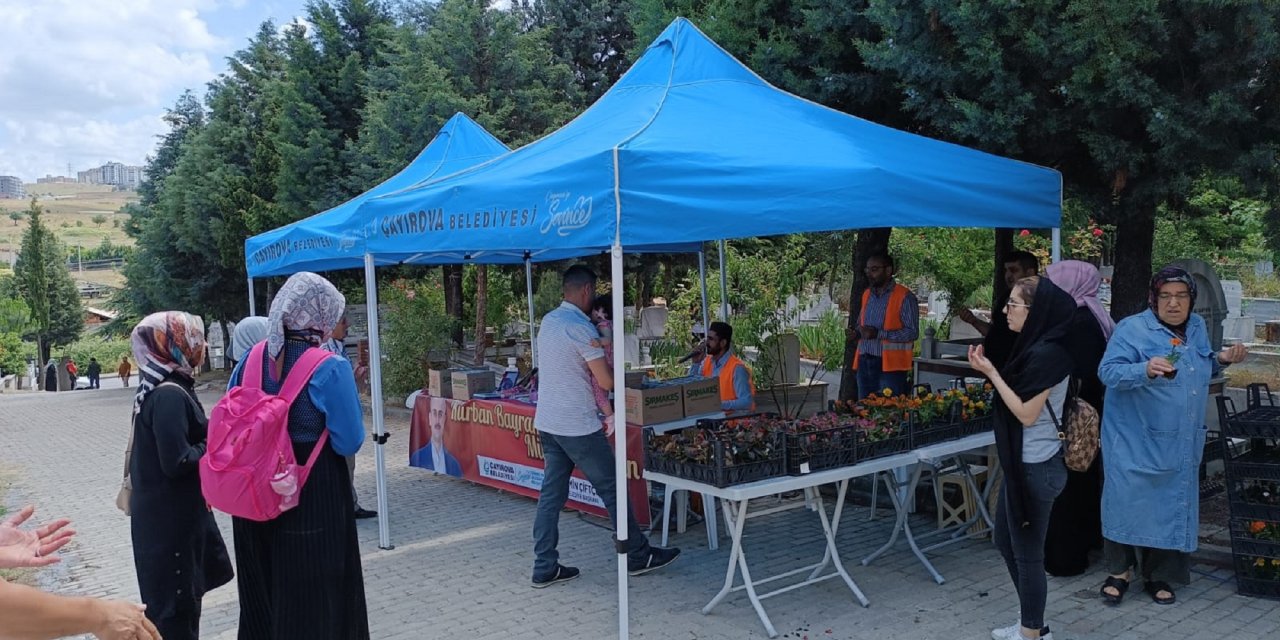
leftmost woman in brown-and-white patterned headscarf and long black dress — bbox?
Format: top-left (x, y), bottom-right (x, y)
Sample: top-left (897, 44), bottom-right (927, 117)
top-left (129, 311), bottom-right (232, 640)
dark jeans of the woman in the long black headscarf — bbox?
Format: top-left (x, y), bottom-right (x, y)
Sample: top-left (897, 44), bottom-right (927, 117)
top-left (992, 452), bottom-right (1066, 628)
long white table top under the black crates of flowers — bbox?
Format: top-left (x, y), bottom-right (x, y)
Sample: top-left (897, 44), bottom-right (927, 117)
top-left (644, 431), bottom-right (996, 500)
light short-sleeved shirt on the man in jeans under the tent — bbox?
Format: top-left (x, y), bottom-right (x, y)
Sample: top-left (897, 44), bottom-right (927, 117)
top-left (534, 302), bottom-right (604, 435)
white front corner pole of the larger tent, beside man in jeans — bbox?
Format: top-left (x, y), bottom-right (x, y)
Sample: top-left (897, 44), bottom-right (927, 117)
top-left (611, 242), bottom-right (629, 640)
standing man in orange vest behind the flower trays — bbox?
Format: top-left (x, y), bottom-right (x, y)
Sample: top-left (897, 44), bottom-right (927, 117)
top-left (854, 253), bottom-right (920, 398)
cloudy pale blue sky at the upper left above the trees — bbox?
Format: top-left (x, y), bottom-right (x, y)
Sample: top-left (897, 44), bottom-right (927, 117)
top-left (0, 0), bottom-right (306, 182)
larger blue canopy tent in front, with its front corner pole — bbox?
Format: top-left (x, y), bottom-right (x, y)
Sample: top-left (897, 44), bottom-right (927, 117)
top-left (345, 18), bottom-right (1061, 637)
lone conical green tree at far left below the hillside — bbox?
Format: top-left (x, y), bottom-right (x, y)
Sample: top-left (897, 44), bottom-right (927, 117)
top-left (13, 198), bottom-right (84, 371)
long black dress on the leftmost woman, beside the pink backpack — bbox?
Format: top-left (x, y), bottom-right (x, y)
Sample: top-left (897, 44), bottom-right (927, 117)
top-left (129, 374), bottom-right (233, 640)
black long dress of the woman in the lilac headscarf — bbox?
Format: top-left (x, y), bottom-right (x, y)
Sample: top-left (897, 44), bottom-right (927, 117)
top-left (1044, 307), bottom-right (1107, 576)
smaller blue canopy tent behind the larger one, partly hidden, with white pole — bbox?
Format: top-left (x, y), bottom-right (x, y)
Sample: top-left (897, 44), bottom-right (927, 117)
top-left (244, 113), bottom-right (509, 548)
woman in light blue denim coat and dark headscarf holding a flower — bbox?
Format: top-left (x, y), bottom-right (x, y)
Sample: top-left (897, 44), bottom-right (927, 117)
top-left (1098, 268), bottom-right (1245, 604)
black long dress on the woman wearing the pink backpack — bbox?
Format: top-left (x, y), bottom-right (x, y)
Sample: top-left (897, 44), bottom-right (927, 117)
top-left (232, 340), bottom-right (369, 640)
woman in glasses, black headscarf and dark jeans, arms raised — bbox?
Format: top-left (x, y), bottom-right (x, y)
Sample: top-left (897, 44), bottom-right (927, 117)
top-left (969, 278), bottom-right (1075, 640)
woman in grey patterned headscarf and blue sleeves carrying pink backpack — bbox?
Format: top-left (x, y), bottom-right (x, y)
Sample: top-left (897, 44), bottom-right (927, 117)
top-left (228, 273), bottom-right (369, 640)
